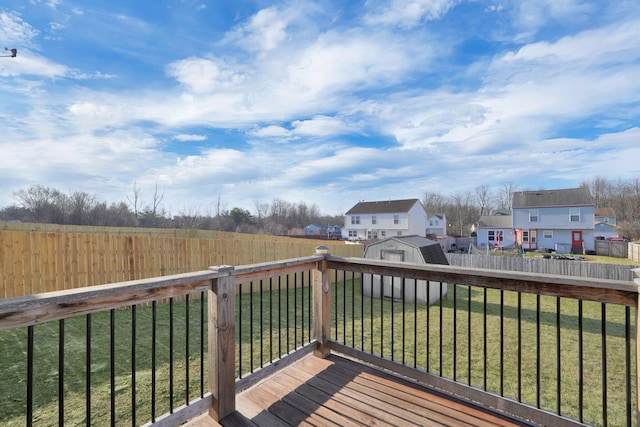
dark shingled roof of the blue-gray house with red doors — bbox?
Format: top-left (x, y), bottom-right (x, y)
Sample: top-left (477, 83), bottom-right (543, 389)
top-left (512, 187), bottom-right (594, 209)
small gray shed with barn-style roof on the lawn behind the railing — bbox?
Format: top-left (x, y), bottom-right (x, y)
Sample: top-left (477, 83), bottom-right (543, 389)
top-left (362, 235), bottom-right (449, 305)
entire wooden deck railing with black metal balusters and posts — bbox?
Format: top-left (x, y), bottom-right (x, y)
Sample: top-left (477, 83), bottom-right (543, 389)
top-left (0, 254), bottom-right (638, 425)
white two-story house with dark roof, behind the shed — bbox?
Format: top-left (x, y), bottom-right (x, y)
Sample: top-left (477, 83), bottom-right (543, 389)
top-left (342, 199), bottom-right (427, 240)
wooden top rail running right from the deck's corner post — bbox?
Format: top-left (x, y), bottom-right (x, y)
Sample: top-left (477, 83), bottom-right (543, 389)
top-left (327, 255), bottom-right (640, 307)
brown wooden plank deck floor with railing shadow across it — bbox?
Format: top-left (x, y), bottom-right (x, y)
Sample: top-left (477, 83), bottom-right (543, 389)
top-left (188, 355), bottom-right (530, 427)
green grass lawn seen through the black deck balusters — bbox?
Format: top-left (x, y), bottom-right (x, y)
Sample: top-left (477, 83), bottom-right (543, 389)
top-left (0, 279), bottom-right (635, 427)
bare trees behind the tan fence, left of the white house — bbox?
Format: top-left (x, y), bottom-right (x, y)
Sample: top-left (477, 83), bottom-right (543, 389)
top-left (0, 185), bottom-right (344, 235)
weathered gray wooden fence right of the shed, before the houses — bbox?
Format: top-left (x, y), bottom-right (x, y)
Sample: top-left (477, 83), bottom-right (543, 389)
top-left (446, 253), bottom-right (635, 281)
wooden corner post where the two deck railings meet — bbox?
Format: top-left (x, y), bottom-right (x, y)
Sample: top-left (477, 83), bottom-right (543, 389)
top-left (312, 246), bottom-right (331, 358)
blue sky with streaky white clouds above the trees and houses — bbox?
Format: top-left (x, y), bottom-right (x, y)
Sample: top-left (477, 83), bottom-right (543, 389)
top-left (0, 0), bottom-right (640, 215)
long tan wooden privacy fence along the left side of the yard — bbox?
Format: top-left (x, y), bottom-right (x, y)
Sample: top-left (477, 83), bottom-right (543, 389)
top-left (0, 230), bottom-right (363, 298)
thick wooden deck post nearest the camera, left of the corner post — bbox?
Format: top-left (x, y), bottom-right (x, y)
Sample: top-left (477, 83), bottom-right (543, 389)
top-left (208, 266), bottom-right (236, 422)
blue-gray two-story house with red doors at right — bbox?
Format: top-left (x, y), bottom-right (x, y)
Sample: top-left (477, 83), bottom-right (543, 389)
top-left (512, 187), bottom-right (595, 253)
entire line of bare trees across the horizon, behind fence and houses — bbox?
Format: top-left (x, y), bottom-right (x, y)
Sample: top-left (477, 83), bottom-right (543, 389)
top-left (0, 178), bottom-right (640, 240)
